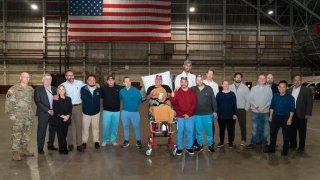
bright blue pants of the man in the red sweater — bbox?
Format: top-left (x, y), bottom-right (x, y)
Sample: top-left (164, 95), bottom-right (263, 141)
top-left (177, 116), bottom-right (194, 150)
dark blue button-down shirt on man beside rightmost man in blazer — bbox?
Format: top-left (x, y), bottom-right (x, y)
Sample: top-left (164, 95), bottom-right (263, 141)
top-left (270, 93), bottom-right (294, 116)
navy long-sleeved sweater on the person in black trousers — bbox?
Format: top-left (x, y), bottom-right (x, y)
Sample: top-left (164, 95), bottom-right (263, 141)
top-left (216, 91), bottom-right (237, 119)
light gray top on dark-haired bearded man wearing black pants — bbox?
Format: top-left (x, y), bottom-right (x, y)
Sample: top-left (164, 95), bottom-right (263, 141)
top-left (229, 83), bottom-right (250, 110)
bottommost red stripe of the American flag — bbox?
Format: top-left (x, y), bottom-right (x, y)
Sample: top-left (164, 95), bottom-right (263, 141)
top-left (68, 36), bottom-right (171, 41)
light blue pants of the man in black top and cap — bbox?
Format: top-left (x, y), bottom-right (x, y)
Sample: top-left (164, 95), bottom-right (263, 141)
top-left (102, 111), bottom-right (120, 143)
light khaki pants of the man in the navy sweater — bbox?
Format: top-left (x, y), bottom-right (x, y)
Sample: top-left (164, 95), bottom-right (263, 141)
top-left (82, 113), bottom-right (100, 143)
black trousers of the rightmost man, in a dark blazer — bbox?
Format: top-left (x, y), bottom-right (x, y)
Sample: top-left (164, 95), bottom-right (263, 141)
top-left (290, 115), bottom-right (307, 150)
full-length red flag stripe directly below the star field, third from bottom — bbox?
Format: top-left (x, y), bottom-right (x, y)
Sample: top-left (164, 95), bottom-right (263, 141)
top-left (69, 20), bottom-right (171, 25)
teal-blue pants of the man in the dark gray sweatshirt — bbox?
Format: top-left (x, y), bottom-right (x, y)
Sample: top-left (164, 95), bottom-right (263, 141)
top-left (195, 114), bottom-right (214, 146)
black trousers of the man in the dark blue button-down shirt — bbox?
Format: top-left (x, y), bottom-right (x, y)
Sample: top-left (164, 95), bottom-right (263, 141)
top-left (269, 115), bottom-right (290, 153)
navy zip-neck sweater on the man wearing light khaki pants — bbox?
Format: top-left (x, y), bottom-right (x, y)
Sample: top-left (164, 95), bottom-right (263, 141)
top-left (80, 86), bottom-right (101, 116)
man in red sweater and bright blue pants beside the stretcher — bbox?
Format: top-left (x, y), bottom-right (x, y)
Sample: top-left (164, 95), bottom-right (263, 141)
top-left (170, 77), bottom-right (197, 156)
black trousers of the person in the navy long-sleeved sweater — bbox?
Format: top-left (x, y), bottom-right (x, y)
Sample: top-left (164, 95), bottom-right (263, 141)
top-left (218, 118), bottom-right (235, 143)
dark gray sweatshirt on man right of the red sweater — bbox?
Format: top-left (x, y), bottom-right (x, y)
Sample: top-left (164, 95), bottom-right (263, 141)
top-left (192, 85), bottom-right (217, 115)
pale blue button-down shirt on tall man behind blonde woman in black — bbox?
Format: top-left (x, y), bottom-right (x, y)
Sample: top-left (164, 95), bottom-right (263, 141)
top-left (62, 80), bottom-right (86, 105)
